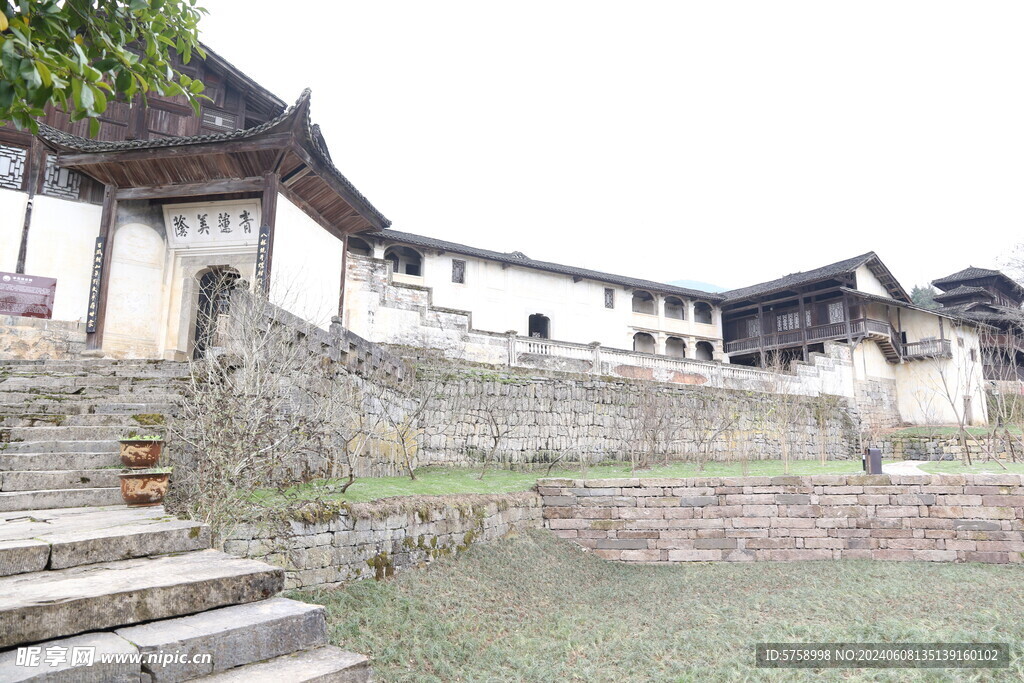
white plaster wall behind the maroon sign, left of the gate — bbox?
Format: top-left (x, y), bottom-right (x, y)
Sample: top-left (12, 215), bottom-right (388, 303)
top-left (25, 195), bottom-right (102, 321)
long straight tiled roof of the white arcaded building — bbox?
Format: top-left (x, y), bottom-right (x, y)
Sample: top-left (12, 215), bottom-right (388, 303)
top-left (360, 230), bottom-right (724, 302)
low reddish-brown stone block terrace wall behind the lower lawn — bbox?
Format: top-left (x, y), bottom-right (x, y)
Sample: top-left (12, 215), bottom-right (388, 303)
top-left (539, 474), bottom-right (1024, 563)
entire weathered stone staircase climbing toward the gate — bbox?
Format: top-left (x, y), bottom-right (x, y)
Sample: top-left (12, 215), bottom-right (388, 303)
top-left (0, 360), bottom-right (371, 683)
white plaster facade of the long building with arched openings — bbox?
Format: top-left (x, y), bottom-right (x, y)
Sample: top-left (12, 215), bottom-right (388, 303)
top-left (360, 249), bottom-right (722, 357)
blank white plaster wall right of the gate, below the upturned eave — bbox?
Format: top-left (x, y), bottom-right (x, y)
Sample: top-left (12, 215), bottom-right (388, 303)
top-left (270, 196), bottom-right (344, 330)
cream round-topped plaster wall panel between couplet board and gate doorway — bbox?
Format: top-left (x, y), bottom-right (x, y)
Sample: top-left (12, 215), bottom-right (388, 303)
top-left (103, 223), bottom-right (167, 357)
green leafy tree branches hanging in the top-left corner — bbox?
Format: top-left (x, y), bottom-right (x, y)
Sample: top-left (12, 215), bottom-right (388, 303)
top-left (0, 0), bottom-right (207, 135)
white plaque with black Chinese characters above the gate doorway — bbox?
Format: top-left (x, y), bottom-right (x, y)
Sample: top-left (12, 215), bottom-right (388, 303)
top-left (164, 200), bottom-right (260, 249)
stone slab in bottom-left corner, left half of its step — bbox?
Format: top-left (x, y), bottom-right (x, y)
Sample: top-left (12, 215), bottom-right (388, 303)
top-left (0, 633), bottom-right (142, 683)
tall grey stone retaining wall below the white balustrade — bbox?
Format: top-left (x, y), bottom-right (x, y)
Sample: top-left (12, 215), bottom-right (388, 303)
top-left (418, 364), bottom-right (859, 466)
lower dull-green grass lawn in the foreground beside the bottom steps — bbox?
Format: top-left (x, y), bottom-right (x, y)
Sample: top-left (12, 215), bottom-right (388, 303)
top-left (292, 530), bottom-right (1024, 682)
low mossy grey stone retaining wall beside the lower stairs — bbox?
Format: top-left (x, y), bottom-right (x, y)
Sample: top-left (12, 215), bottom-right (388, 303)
top-left (224, 492), bottom-right (543, 589)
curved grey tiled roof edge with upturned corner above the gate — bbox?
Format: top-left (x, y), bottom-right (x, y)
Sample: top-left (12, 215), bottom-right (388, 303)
top-left (39, 88), bottom-right (391, 227)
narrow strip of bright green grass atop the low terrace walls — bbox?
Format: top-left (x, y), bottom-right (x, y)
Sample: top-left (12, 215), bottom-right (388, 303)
top-left (257, 459), bottom-right (863, 503)
